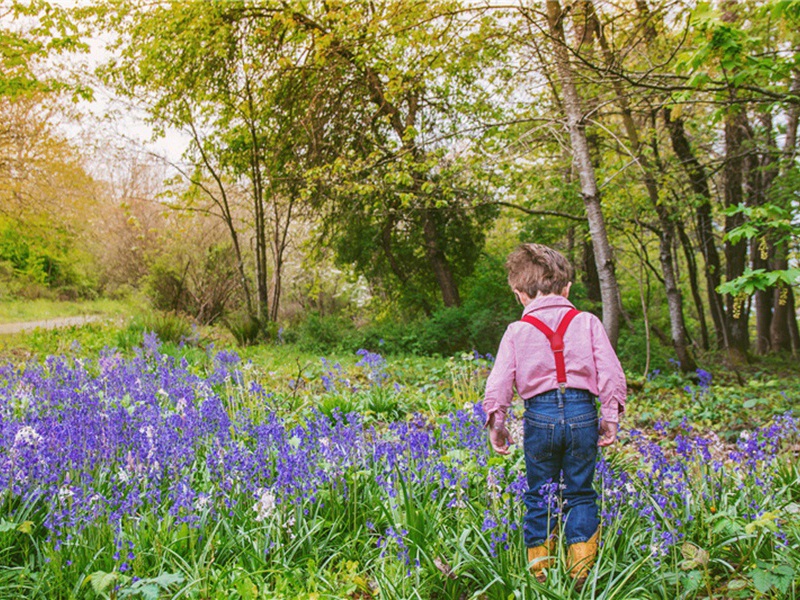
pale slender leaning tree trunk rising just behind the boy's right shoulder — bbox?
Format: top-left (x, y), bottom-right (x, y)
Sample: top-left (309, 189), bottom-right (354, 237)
top-left (547, 0), bottom-right (621, 346)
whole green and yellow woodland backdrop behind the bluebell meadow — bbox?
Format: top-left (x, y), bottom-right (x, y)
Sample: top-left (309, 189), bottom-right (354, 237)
top-left (0, 0), bottom-right (800, 370)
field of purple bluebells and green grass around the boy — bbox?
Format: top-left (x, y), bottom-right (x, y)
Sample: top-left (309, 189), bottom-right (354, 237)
top-left (0, 336), bottom-right (800, 600)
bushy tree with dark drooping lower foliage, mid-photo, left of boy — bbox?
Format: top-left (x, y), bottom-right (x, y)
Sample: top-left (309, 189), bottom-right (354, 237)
top-left (273, 0), bottom-right (510, 310)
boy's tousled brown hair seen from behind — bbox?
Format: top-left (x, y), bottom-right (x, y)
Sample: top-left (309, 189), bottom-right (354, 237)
top-left (506, 244), bottom-right (574, 298)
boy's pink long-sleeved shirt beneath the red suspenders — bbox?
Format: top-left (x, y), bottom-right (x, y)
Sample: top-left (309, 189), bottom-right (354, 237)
top-left (483, 295), bottom-right (627, 424)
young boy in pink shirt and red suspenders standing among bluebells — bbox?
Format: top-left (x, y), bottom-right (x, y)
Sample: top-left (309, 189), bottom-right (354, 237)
top-left (483, 244), bottom-right (627, 587)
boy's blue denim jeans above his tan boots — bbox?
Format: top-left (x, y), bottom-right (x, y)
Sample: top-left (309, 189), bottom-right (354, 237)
top-left (522, 388), bottom-right (600, 548)
